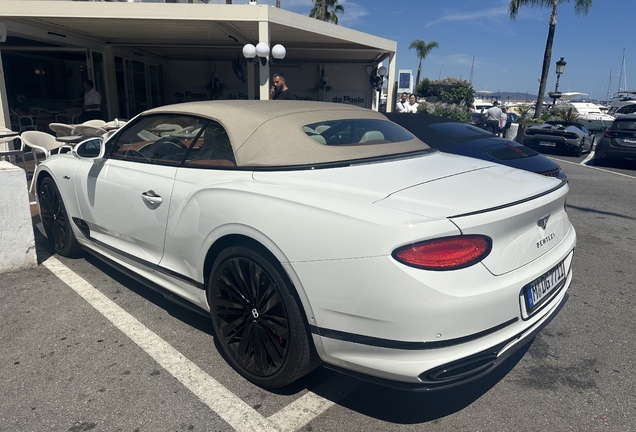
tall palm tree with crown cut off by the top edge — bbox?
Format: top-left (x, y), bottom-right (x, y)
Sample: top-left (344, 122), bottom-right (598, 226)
top-left (508, 0), bottom-right (592, 118)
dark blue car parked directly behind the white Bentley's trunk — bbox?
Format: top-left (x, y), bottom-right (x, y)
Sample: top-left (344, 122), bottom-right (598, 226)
top-left (386, 113), bottom-right (565, 178)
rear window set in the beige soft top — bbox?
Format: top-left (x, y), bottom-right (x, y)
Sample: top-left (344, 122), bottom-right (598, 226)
top-left (303, 119), bottom-right (415, 146)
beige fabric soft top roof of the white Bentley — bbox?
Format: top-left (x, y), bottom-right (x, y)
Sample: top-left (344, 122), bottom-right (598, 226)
top-left (146, 100), bottom-right (429, 167)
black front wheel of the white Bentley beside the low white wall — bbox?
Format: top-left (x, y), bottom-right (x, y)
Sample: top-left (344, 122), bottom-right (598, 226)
top-left (38, 177), bottom-right (81, 256)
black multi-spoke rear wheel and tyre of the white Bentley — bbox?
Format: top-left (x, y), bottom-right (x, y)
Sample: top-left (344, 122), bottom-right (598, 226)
top-left (208, 246), bottom-right (317, 388)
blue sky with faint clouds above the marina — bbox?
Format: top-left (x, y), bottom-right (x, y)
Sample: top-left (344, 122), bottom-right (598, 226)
top-left (235, 0), bottom-right (636, 100)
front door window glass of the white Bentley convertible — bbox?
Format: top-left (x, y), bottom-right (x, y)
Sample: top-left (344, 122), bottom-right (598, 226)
top-left (106, 114), bottom-right (208, 165)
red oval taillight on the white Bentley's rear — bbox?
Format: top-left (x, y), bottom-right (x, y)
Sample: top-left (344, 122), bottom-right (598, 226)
top-left (392, 235), bottom-right (492, 270)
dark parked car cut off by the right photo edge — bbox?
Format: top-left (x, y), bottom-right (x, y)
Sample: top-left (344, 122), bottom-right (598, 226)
top-left (594, 114), bottom-right (636, 163)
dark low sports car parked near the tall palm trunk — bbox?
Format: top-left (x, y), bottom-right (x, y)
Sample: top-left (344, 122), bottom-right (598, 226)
top-left (523, 120), bottom-right (594, 156)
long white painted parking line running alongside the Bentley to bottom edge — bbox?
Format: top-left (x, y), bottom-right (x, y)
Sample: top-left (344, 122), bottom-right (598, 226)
top-left (42, 257), bottom-right (278, 432)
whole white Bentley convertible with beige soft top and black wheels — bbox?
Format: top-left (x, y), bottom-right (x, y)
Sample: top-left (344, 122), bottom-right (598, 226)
top-left (34, 101), bottom-right (576, 389)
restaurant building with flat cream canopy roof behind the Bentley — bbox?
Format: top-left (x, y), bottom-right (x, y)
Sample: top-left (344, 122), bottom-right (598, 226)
top-left (0, 0), bottom-right (396, 127)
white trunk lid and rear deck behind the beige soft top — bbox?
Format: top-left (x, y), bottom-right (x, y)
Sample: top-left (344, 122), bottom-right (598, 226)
top-left (254, 153), bottom-right (561, 219)
